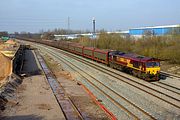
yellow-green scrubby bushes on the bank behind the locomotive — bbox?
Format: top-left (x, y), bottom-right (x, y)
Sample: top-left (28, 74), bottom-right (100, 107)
top-left (76, 33), bottom-right (180, 64)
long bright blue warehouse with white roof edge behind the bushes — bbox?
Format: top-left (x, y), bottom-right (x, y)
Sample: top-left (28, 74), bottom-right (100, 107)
top-left (129, 25), bottom-right (180, 37)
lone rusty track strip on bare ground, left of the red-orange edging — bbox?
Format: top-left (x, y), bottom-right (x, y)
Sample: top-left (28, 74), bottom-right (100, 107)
top-left (36, 52), bottom-right (87, 120)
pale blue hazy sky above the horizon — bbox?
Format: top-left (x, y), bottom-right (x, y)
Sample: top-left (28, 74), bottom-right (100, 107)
top-left (0, 0), bottom-right (180, 32)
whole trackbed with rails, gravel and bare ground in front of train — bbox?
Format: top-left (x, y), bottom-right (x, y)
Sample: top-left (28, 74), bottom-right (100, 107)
top-left (1, 39), bottom-right (180, 120)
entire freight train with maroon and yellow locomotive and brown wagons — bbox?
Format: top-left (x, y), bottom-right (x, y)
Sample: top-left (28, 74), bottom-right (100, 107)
top-left (20, 39), bottom-right (160, 81)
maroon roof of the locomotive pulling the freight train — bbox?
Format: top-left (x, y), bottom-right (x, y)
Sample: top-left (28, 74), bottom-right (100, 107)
top-left (110, 51), bottom-right (158, 62)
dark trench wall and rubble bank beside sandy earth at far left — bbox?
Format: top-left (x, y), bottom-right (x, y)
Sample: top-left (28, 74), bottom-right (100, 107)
top-left (0, 45), bottom-right (29, 114)
